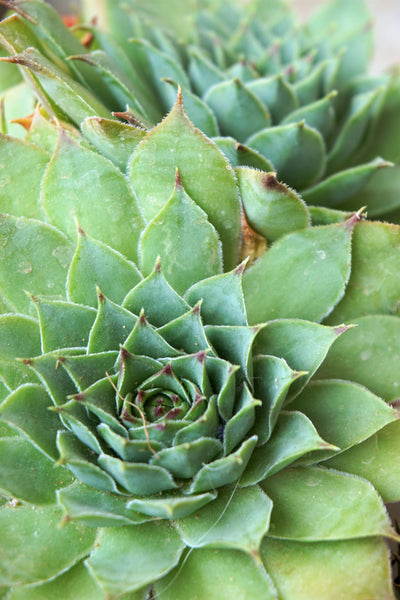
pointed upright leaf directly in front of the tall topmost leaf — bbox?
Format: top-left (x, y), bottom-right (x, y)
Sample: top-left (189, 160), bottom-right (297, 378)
top-left (140, 174), bottom-right (222, 293)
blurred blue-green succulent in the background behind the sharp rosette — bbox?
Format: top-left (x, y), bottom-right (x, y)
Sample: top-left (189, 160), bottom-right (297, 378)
top-left (0, 0), bottom-right (400, 222)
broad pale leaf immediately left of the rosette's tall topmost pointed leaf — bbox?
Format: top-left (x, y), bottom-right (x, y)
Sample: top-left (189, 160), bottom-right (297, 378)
top-left (41, 128), bottom-right (143, 260)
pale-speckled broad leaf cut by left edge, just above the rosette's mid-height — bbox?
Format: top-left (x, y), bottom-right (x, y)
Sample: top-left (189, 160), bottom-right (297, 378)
top-left (0, 215), bottom-right (72, 312)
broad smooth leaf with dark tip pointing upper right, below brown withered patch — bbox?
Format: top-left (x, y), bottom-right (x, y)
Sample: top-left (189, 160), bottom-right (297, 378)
top-left (243, 216), bottom-right (358, 323)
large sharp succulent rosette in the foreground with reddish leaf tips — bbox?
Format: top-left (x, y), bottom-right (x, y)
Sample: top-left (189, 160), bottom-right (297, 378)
top-left (0, 1), bottom-right (400, 600)
